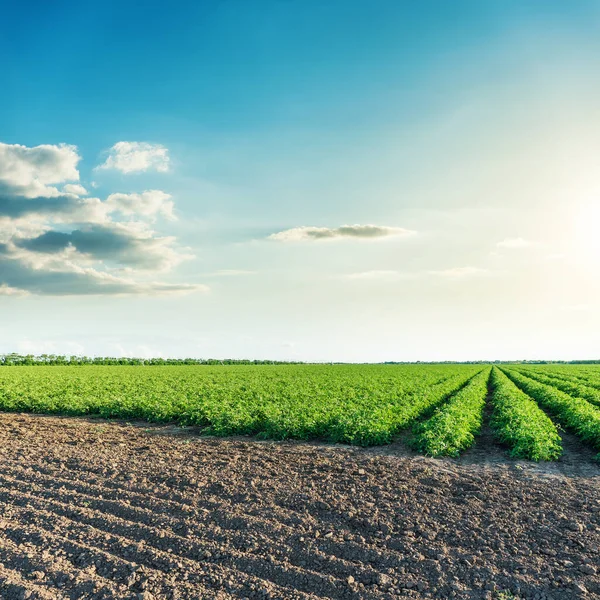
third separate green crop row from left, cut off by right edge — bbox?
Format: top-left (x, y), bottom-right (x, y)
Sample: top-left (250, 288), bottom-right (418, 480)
top-left (502, 368), bottom-right (600, 450)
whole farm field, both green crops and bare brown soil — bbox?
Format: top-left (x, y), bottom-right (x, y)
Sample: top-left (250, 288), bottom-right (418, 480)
top-left (0, 365), bottom-right (600, 600)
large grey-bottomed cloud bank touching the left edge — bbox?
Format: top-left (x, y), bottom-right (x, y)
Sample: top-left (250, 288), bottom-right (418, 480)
top-left (0, 144), bottom-right (202, 296)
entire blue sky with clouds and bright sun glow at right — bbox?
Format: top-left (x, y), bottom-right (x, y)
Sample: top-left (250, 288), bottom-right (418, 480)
top-left (0, 0), bottom-right (600, 362)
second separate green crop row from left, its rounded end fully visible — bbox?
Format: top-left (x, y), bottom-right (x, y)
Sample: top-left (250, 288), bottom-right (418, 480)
top-left (490, 367), bottom-right (562, 461)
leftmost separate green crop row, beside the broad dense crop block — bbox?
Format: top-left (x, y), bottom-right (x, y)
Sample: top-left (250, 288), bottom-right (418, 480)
top-left (411, 369), bottom-right (490, 456)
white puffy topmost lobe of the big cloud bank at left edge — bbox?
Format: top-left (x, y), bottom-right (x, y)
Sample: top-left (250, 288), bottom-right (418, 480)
top-left (0, 142), bottom-right (81, 198)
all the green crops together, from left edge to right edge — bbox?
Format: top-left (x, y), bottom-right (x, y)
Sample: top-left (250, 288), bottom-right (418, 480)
top-left (0, 365), bottom-right (600, 460)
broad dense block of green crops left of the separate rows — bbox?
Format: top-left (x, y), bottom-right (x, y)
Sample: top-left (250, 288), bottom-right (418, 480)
top-left (0, 365), bottom-right (481, 446)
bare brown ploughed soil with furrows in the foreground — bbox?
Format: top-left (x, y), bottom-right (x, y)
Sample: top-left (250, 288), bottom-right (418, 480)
top-left (0, 414), bottom-right (600, 600)
